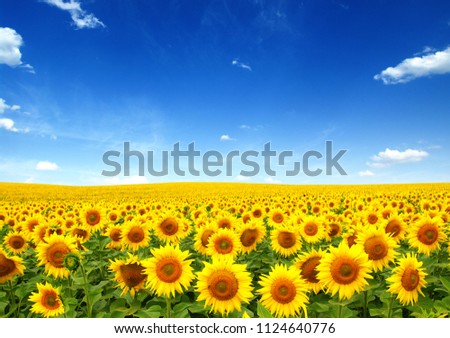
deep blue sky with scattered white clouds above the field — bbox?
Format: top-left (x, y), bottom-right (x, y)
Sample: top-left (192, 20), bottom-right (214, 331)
top-left (0, 0), bottom-right (450, 185)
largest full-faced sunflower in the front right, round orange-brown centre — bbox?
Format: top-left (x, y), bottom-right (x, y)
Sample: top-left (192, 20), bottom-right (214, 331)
top-left (317, 242), bottom-right (372, 299)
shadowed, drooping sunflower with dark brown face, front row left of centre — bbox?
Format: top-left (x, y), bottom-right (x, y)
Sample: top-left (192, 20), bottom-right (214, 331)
top-left (109, 253), bottom-right (147, 297)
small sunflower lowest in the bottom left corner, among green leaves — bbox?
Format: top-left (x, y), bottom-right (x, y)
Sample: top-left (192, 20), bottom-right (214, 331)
top-left (29, 283), bottom-right (64, 318)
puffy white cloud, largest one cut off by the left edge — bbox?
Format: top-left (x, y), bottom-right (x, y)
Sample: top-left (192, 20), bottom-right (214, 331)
top-left (0, 27), bottom-right (23, 67)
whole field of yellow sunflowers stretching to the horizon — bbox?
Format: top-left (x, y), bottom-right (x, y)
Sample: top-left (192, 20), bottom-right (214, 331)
top-left (0, 183), bottom-right (450, 318)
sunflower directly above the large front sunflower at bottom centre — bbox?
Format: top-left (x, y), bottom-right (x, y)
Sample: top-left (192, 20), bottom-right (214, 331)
top-left (206, 229), bottom-right (241, 257)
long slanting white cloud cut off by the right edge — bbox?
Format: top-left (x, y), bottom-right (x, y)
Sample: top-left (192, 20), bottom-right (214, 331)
top-left (374, 47), bottom-right (450, 84)
